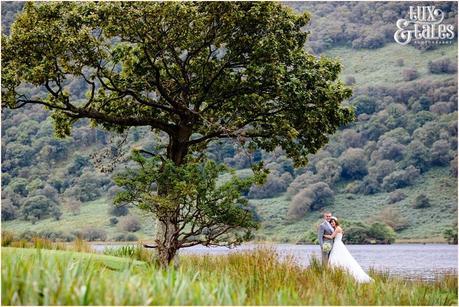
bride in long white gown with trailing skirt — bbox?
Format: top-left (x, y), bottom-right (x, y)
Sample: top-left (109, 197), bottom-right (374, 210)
top-left (324, 217), bottom-right (373, 282)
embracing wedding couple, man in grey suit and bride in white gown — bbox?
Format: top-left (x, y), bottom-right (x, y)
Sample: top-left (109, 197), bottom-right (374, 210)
top-left (318, 211), bottom-right (373, 282)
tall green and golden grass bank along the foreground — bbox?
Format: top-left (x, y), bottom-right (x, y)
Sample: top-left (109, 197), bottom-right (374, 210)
top-left (2, 247), bottom-right (457, 305)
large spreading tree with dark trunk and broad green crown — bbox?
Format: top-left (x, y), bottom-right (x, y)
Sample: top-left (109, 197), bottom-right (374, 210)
top-left (2, 2), bottom-right (353, 263)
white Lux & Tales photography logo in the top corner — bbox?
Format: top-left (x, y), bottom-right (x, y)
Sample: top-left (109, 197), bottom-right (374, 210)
top-left (394, 5), bottom-right (455, 45)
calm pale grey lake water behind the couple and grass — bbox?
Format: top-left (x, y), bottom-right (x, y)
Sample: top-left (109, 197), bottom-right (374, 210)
top-left (94, 244), bottom-right (458, 279)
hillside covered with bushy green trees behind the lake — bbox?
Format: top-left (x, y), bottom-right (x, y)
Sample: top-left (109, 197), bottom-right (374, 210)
top-left (1, 2), bottom-right (458, 243)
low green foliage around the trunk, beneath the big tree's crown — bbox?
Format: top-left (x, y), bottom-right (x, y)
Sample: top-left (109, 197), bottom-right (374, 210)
top-left (115, 151), bottom-right (265, 246)
